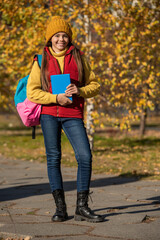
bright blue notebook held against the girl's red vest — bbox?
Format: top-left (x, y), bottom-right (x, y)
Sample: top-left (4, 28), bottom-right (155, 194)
top-left (51, 74), bottom-right (72, 101)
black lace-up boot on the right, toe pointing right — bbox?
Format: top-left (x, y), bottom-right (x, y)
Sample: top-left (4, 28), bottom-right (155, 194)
top-left (74, 191), bottom-right (104, 222)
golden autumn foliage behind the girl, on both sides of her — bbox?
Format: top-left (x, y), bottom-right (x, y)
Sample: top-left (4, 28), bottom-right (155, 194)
top-left (0, 0), bottom-right (160, 137)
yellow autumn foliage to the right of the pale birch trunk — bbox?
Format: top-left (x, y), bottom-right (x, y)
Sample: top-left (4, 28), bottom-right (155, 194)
top-left (92, 0), bottom-right (160, 133)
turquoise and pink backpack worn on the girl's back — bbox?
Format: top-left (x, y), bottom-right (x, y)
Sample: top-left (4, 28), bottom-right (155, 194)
top-left (14, 55), bottom-right (42, 139)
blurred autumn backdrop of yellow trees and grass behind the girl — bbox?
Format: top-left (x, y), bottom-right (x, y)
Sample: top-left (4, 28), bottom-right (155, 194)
top-left (0, 0), bottom-right (160, 179)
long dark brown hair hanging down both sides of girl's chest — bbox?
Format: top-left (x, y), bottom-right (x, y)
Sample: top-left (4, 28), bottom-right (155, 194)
top-left (41, 41), bottom-right (85, 91)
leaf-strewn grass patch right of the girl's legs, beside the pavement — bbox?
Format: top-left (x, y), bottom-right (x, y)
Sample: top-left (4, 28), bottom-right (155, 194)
top-left (94, 136), bottom-right (160, 179)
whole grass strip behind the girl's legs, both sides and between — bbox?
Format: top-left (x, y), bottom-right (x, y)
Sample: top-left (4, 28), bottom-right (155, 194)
top-left (0, 131), bottom-right (160, 179)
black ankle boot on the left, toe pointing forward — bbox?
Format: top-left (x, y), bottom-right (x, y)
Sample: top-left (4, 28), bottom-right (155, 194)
top-left (52, 189), bottom-right (68, 222)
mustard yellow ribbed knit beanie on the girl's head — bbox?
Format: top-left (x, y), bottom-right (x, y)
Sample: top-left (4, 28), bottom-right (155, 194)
top-left (46, 16), bottom-right (72, 43)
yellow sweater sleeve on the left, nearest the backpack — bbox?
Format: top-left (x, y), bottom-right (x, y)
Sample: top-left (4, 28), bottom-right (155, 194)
top-left (27, 61), bottom-right (56, 104)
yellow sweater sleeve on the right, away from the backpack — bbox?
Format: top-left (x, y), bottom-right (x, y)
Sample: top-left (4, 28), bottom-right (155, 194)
top-left (79, 55), bottom-right (100, 98)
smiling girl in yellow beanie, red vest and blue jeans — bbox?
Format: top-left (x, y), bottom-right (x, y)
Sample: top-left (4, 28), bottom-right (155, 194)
top-left (27, 16), bottom-right (103, 222)
